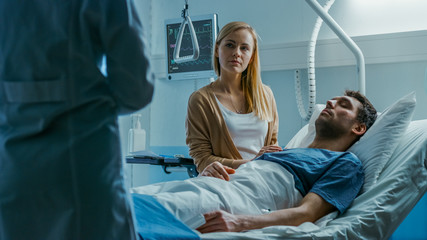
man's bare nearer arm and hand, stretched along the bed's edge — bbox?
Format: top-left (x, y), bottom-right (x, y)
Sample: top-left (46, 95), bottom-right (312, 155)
top-left (197, 192), bottom-right (336, 233)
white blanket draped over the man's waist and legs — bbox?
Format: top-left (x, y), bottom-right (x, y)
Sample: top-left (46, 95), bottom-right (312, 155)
top-left (131, 160), bottom-right (302, 228)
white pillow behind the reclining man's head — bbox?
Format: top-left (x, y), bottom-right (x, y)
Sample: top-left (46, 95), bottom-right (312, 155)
top-left (286, 92), bottom-right (416, 192)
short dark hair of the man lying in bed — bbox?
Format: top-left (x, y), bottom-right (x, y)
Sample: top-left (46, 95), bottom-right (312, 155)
top-left (344, 90), bottom-right (377, 130)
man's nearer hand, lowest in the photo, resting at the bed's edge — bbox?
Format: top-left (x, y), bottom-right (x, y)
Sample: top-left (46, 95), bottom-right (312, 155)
top-left (196, 210), bottom-right (245, 233)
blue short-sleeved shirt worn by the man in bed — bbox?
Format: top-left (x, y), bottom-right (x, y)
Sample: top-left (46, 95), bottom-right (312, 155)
top-left (258, 148), bottom-right (364, 213)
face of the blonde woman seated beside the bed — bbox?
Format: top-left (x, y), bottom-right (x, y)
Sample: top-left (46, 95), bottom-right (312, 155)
top-left (215, 29), bottom-right (254, 74)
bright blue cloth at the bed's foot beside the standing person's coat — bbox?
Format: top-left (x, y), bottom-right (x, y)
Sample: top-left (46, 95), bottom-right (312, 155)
top-left (132, 193), bottom-right (200, 240)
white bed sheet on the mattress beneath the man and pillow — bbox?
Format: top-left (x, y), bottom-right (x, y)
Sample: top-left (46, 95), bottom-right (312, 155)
top-left (200, 119), bottom-right (427, 240)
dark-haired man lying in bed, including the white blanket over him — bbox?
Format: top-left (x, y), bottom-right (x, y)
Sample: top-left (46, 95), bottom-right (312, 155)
top-left (133, 91), bottom-right (376, 233)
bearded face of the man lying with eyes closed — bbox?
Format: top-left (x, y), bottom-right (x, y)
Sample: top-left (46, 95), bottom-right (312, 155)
top-left (316, 96), bottom-right (362, 137)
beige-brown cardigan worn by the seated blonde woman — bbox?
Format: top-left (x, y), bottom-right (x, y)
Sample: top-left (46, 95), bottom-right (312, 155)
top-left (185, 84), bottom-right (279, 172)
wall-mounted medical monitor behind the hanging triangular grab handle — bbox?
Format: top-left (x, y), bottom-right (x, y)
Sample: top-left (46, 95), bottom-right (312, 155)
top-left (165, 14), bottom-right (218, 80)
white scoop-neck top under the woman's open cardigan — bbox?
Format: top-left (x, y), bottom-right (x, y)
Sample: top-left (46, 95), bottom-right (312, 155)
top-left (215, 97), bottom-right (268, 160)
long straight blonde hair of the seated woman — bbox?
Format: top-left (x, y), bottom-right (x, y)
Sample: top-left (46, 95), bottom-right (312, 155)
top-left (212, 22), bottom-right (273, 121)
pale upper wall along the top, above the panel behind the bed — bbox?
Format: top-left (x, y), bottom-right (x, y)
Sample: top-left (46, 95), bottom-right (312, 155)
top-left (143, 0), bottom-right (427, 55)
